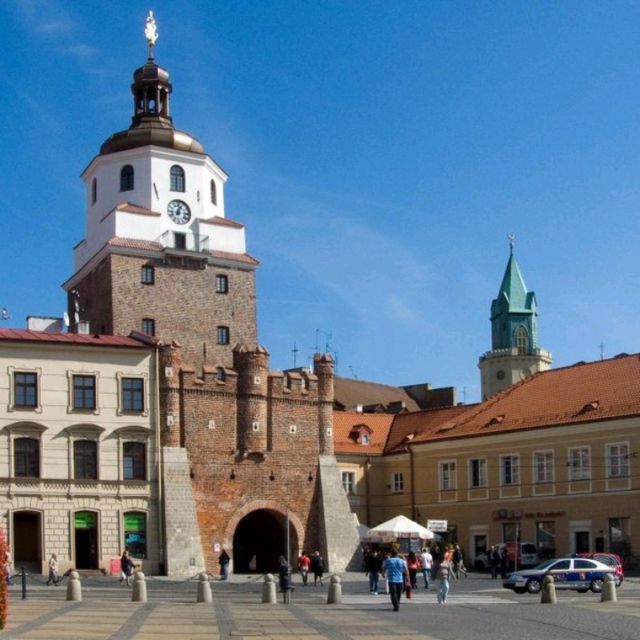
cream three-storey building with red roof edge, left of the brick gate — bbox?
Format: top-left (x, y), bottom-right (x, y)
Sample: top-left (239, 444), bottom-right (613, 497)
top-left (0, 330), bottom-right (162, 573)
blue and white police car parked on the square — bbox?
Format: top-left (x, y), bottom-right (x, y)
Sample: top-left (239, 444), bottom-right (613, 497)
top-left (502, 558), bottom-right (620, 593)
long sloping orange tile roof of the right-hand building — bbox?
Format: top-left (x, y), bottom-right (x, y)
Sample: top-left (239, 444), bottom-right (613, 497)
top-left (408, 354), bottom-right (640, 442)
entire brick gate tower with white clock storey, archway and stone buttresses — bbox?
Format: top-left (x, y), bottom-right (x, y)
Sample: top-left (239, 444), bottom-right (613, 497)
top-left (64, 14), bottom-right (359, 576)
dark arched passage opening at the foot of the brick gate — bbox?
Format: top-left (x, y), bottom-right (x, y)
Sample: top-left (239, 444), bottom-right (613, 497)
top-left (233, 509), bottom-right (298, 573)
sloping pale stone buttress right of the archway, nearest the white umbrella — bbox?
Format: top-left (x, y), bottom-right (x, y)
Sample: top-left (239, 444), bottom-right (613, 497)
top-left (318, 455), bottom-right (362, 573)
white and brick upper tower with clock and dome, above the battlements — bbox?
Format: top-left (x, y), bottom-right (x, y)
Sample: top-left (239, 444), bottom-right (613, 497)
top-left (63, 16), bottom-right (258, 367)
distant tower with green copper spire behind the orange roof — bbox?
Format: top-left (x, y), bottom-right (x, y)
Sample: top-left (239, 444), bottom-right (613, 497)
top-left (478, 241), bottom-right (551, 400)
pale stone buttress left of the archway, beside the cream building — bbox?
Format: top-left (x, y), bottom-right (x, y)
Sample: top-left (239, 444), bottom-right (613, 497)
top-left (162, 447), bottom-right (205, 577)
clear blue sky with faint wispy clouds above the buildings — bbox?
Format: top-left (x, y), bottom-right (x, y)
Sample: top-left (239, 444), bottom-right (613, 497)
top-left (0, 0), bottom-right (640, 401)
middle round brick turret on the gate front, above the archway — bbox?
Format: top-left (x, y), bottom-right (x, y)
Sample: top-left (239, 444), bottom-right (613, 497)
top-left (233, 344), bottom-right (269, 455)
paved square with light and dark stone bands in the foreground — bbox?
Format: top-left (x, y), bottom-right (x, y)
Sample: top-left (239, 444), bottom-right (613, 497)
top-left (0, 574), bottom-right (640, 640)
